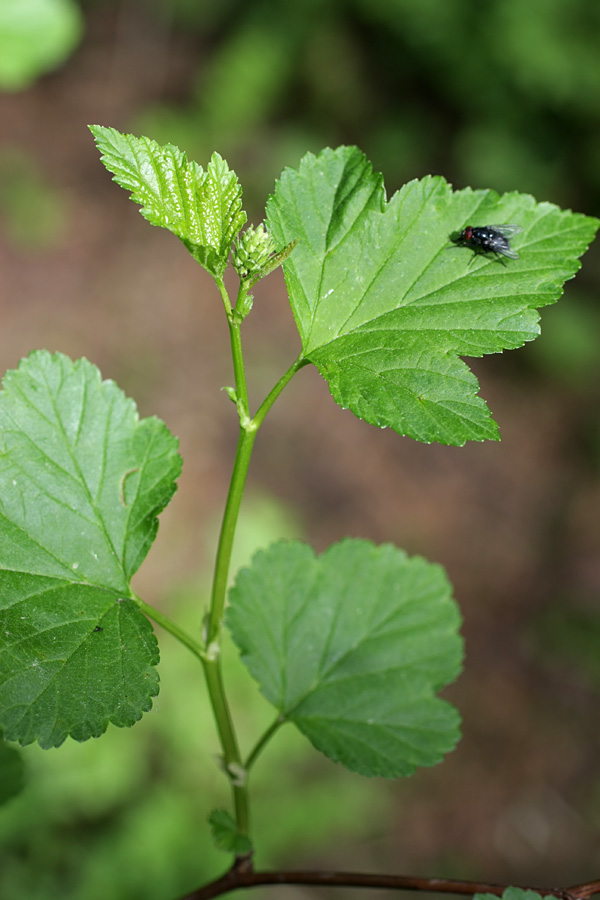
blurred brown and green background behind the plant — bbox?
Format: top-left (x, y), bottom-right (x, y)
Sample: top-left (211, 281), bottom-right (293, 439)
top-left (0, 0), bottom-right (600, 900)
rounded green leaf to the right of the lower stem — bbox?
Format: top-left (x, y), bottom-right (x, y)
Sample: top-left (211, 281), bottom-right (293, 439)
top-left (226, 540), bottom-right (462, 778)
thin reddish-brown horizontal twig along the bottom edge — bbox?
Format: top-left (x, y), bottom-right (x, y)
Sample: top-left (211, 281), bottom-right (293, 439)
top-left (180, 858), bottom-right (600, 900)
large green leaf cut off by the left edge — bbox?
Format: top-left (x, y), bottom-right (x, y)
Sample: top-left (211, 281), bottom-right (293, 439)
top-left (0, 351), bottom-right (181, 747)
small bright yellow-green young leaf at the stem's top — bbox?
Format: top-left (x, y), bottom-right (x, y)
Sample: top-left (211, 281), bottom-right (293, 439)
top-left (90, 125), bottom-right (246, 278)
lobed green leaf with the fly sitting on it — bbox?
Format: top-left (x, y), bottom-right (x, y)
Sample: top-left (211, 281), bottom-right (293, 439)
top-left (266, 147), bottom-right (600, 445)
